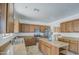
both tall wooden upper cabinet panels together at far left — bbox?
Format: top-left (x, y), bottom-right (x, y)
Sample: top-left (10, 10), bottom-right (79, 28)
top-left (0, 3), bottom-right (14, 33)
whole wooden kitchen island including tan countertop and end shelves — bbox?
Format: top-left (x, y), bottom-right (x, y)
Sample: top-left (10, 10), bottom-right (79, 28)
top-left (39, 38), bottom-right (69, 55)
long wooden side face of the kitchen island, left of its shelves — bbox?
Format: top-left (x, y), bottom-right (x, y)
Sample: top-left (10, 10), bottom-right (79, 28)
top-left (39, 40), bottom-right (59, 55)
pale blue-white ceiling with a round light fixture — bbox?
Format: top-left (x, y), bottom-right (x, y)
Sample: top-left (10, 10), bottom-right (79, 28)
top-left (14, 3), bottom-right (79, 23)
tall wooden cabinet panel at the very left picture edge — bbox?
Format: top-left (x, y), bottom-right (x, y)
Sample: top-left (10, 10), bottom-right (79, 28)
top-left (0, 3), bottom-right (7, 33)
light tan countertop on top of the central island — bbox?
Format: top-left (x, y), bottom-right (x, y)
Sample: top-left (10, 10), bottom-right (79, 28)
top-left (39, 38), bottom-right (69, 48)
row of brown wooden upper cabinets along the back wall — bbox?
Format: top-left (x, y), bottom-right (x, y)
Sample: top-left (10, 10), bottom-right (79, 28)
top-left (19, 23), bottom-right (47, 32)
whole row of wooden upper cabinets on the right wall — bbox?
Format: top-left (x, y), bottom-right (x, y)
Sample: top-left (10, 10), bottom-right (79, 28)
top-left (60, 19), bottom-right (79, 32)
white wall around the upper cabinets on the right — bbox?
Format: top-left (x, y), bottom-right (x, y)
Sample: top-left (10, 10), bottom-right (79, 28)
top-left (50, 14), bottom-right (79, 37)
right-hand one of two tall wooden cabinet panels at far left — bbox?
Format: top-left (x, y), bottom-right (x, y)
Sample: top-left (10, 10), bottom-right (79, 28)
top-left (6, 4), bottom-right (14, 33)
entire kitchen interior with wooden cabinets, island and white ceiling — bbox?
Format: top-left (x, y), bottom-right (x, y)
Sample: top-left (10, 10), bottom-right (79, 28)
top-left (0, 3), bottom-right (79, 55)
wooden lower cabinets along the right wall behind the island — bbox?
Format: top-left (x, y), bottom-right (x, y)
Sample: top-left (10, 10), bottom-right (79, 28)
top-left (59, 38), bottom-right (79, 53)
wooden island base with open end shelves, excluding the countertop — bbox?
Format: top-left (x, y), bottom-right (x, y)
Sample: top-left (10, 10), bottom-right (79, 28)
top-left (38, 40), bottom-right (68, 55)
